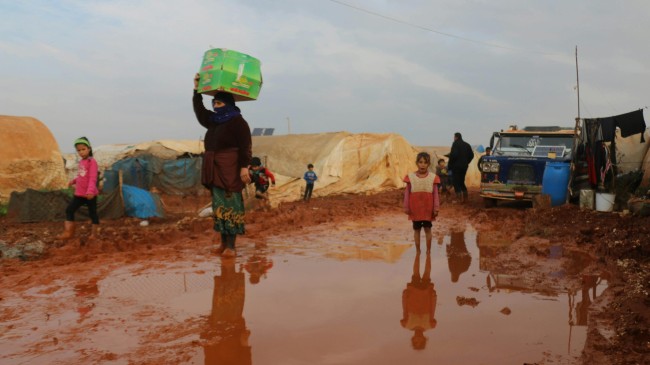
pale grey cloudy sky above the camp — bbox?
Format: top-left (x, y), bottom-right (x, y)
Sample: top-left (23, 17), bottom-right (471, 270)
top-left (0, 0), bottom-right (650, 152)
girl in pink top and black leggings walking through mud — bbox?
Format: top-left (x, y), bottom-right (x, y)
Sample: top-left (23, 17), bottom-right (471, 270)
top-left (57, 137), bottom-right (99, 240)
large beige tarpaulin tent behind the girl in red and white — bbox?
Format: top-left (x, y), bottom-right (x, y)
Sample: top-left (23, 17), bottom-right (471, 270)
top-left (253, 132), bottom-right (418, 202)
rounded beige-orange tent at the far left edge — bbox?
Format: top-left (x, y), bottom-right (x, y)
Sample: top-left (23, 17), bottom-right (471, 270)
top-left (0, 115), bottom-right (67, 203)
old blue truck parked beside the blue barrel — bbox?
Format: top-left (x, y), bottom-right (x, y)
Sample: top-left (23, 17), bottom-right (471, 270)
top-left (479, 126), bottom-right (575, 207)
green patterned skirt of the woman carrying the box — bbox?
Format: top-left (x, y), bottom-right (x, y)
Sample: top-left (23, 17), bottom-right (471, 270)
top-left (212, 187), bottom-right (246, 235)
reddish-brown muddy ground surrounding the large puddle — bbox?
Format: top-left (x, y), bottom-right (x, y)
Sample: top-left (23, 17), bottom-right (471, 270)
top-left (0, 191), bottom-right (650, 364)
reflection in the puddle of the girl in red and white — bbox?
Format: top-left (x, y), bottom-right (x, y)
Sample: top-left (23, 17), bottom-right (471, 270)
top-left (400, 252), bottom-right (438, 350)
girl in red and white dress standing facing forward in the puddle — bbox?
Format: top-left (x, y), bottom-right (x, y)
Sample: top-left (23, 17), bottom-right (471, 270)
top-left (404, 152), bottom-right (440, 253)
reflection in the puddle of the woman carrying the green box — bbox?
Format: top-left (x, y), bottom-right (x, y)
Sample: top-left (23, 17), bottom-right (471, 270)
top-left (201, 258), bottom-right (252, 365)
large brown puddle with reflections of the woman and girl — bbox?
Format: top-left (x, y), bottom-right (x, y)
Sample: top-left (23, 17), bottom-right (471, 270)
top-left (0, 218), bottom-right (606, 365)
